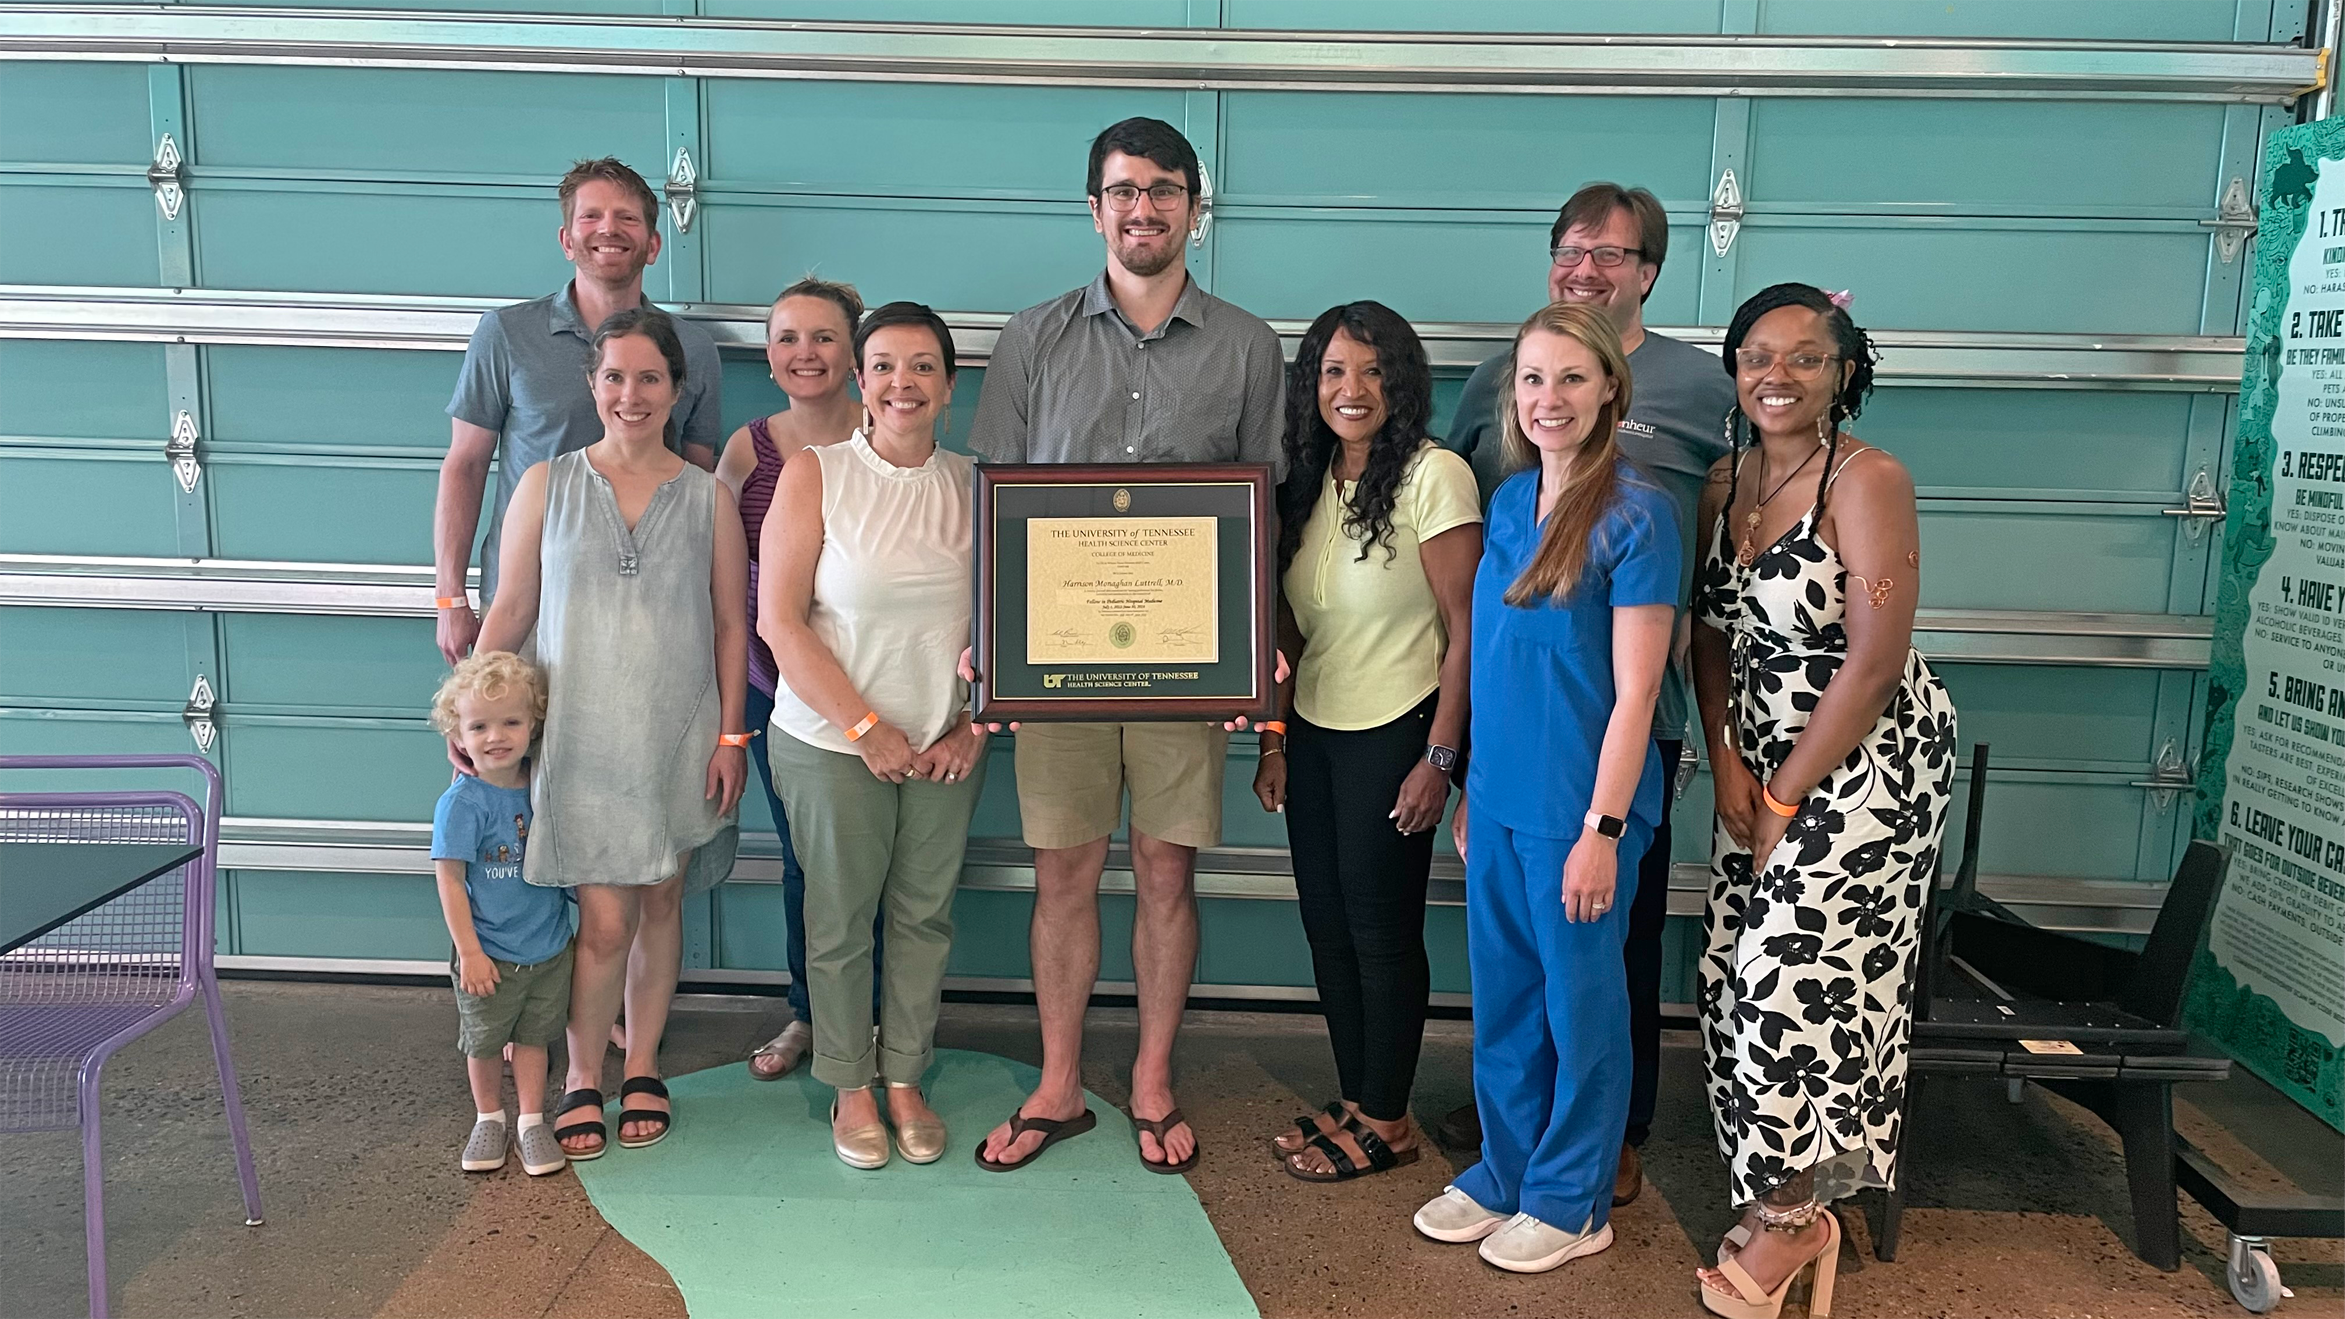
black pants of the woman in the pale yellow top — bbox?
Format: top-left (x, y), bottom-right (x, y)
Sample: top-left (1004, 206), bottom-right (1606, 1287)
top-left (1287, 697), bottom-right (1440, 1122)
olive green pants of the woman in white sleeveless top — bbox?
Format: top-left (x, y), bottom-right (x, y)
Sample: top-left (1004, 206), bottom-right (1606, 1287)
top-left (767, 732), bottom-right (985, 1089)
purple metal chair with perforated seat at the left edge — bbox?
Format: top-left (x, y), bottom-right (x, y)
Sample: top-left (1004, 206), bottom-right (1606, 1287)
top-left (0, 756), bottom-right (260, 1319)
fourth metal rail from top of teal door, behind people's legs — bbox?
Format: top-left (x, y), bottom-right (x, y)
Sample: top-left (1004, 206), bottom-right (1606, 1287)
top-left (220, 817), bottom-right (2164, 934)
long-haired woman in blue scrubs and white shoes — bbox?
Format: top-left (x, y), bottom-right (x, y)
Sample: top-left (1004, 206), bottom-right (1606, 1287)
top-left (1416, 303), bottom-right (1681, 1272)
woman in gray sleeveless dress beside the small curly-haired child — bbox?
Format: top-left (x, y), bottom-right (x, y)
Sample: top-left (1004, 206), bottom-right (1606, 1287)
top-left (478, 310), bottom-right (748, 1159)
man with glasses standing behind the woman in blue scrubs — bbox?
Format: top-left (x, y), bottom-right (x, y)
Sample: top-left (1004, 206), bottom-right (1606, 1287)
top-left (1442, 183), bottom-right (1735, 1204)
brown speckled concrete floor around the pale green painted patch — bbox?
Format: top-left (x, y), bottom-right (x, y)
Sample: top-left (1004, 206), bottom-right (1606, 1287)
top-left (0, 981), bottom-right (2345, 1319)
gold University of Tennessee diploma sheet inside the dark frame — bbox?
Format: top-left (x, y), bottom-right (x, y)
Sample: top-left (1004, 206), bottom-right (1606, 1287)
top-left (1027, 516), bottom-right (1222, 664)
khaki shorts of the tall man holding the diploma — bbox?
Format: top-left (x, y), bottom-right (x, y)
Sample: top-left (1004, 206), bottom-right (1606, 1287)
top-left (1018, 723), bottom-right (1229, 847)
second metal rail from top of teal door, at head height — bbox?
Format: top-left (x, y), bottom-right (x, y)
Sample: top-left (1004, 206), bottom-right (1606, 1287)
top-left (0, 284), bottom-right (2244, 392)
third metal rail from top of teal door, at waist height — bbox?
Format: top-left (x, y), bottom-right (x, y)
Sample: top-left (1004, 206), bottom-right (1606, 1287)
top-left (0, 554), bottom-right (2214, 669)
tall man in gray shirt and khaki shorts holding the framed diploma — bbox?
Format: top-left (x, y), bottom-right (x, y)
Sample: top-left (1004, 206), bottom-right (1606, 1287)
top-left (968, 120), bottom-right (1285, 1171)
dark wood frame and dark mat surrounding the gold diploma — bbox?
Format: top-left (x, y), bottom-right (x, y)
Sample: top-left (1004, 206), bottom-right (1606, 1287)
top-left (971, 462), bottom-right (1278, 723)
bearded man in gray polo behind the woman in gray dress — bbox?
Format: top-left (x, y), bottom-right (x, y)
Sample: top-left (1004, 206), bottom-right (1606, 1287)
top-left (431, 155), bottom-right (725, 664)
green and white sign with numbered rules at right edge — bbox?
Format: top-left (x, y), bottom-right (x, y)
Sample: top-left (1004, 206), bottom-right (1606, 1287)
top-left (2190, 110), bottom-right (2345, 1129)
